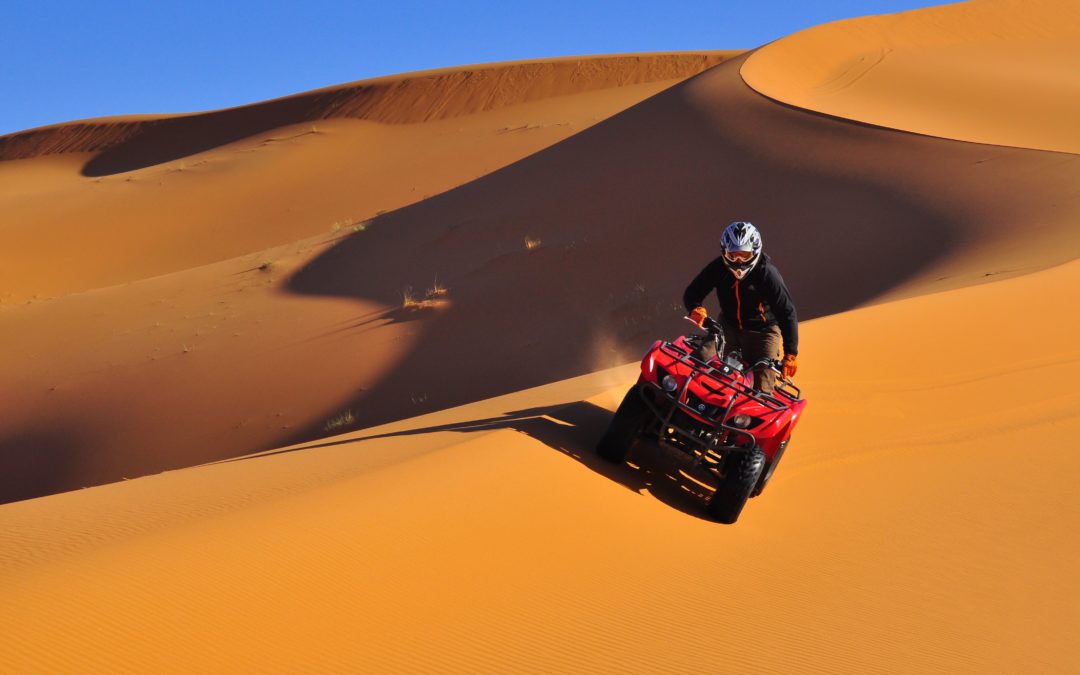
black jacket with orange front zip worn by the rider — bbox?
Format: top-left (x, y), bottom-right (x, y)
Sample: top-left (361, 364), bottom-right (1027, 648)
top-left (683, 254), bottom-right (799, 354)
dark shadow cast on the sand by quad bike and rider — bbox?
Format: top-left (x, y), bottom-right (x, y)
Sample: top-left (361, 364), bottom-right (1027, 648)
top-left (232, 401), bottom-right (711, 521)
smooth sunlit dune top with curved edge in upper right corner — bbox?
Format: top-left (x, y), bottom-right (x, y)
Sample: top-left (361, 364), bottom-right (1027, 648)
top-left (742, 0), bottom-right (1080, 153)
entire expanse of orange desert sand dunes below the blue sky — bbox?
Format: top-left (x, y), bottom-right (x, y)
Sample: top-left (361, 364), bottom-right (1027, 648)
top-left (0, 0), bottom-right (1080, 673)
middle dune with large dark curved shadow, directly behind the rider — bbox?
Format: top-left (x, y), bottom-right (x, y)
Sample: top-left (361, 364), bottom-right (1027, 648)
top-left (0, 51), bottom-right (1080, 501)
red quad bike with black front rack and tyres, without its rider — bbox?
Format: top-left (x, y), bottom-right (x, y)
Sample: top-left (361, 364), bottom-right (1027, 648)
top-left (596, 319), bottom-right (807, 524)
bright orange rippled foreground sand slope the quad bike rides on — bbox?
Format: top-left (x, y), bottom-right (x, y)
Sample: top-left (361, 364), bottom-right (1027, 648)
top-left (0, 259), bottom-right (1080, 673)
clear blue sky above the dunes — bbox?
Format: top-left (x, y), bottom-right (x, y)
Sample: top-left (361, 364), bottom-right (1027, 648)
top-left (0, 0), bottom-right (941, 134)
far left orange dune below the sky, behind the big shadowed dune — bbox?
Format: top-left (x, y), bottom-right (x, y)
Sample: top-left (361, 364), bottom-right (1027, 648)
top-left (0, 52), bottom-right (732, 303)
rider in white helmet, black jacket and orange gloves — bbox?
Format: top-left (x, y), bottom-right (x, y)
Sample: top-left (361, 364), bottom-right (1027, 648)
top-left (683, 220), bottom-right (799, 393)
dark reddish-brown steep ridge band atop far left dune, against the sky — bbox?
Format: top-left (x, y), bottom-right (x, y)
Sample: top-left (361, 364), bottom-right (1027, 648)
top-left (0, 52), bottom-right (733, 176)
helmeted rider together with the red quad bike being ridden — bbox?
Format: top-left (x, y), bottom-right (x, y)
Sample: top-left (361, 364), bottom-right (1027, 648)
top-left (596, 222), bottom-right (806, 523)
